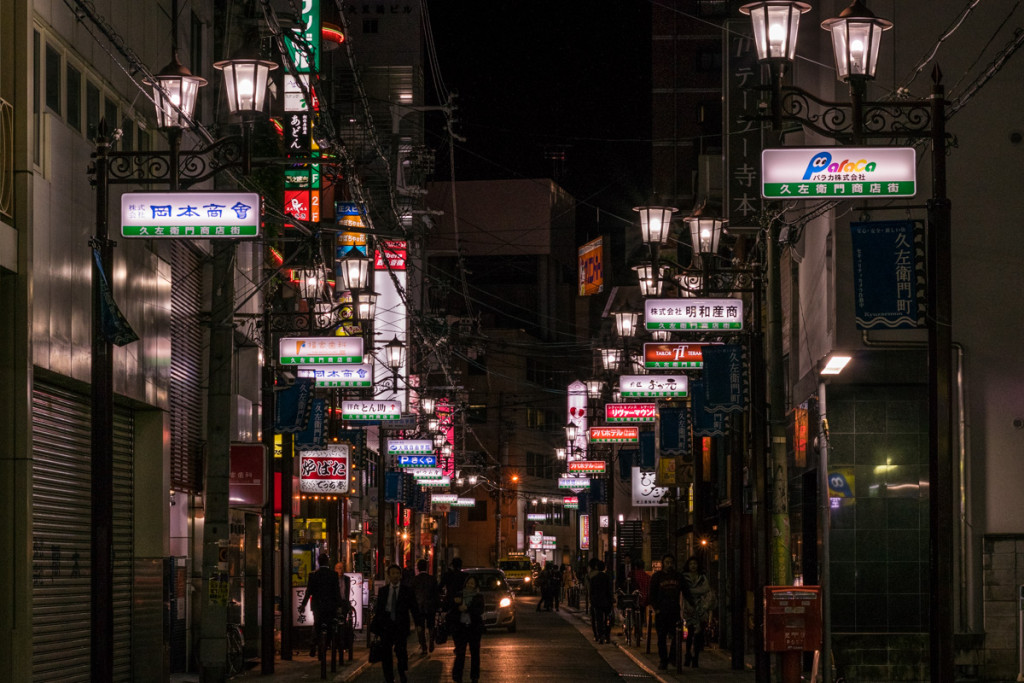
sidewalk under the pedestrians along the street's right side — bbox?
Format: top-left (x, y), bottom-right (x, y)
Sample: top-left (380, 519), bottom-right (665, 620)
top-left (559, 604), bottom-right (755, 683)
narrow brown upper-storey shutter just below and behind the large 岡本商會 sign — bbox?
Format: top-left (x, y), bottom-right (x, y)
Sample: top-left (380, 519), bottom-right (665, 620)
top-left (170, 243), bottom-right (204, 493)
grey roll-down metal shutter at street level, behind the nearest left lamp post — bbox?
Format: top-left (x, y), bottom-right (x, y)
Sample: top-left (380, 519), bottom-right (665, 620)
top-left (32, 382), bottom-right (134, 681)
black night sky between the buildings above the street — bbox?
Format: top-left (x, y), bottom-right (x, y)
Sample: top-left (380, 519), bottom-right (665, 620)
top-left (427, 0), bottom-right (650, 231)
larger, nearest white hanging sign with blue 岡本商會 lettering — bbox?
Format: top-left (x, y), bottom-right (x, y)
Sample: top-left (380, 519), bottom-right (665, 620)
top-left (121, 193), bottom-right (260, 240)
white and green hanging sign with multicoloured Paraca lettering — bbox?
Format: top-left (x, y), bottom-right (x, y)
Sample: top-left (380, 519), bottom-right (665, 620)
top-left (761, 147), bottom-right (918, 200)
